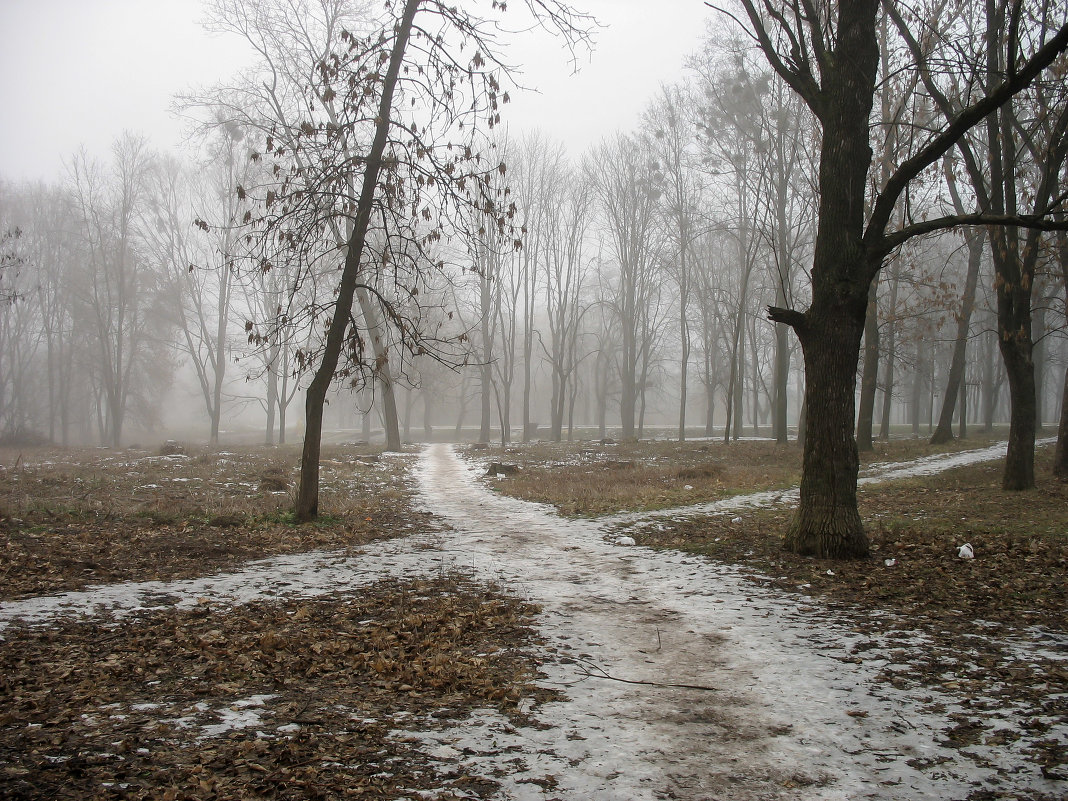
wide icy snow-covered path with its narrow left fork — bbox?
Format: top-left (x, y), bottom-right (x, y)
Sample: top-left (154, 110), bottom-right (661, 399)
top-left (0, 444), bottom-right (1052, 801)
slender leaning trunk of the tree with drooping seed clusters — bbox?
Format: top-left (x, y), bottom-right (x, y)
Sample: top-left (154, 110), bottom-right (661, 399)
top-left (294, 0), bottom-right (422, 522)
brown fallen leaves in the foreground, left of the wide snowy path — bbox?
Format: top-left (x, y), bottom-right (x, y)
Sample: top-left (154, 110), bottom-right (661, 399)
top-left (0, 577), bottom-right (550, 801)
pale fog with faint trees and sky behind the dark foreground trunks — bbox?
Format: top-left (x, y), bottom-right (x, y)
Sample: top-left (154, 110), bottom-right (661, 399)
top-left (0, 0), bottom-right (1068, 446)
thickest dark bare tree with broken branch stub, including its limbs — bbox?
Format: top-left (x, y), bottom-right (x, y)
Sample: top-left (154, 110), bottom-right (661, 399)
top-left (717, 0), bottom-right (1068, 557)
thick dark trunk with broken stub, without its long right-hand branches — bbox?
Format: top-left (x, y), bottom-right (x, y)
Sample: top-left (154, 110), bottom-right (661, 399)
top-left (769, 0), bottom-right (883, 559)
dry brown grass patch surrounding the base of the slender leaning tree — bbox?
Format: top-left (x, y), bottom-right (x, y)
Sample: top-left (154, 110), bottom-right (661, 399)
top-left (0, 446), bottom-right (433, 598)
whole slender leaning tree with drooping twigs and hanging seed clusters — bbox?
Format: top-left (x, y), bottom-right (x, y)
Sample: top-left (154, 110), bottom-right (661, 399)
top-left (218, 0), bottom-right (582, 520)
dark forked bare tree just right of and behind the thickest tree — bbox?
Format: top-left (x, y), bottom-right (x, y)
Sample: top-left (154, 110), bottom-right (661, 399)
top-left (889, 0), bottom-right (1068, 490)
